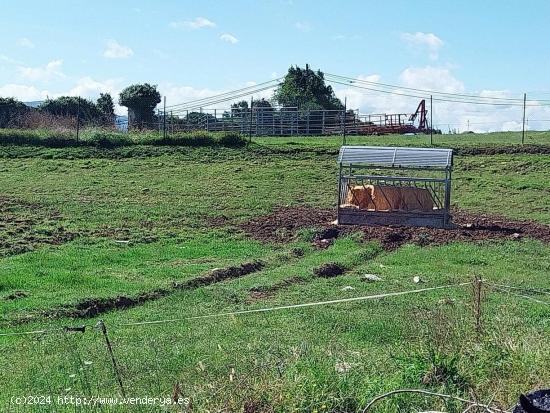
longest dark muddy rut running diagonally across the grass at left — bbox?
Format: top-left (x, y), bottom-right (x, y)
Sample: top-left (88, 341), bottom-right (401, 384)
top-left (33, 261), bottom-right (264, 322)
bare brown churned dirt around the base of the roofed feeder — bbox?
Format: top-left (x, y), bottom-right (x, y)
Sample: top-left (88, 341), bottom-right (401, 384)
top-left (241, 207), bottom-right (550, 251)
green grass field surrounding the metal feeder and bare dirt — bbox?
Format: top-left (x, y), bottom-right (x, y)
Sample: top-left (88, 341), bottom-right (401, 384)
top-left (0, 132), bottom-right (550, 413)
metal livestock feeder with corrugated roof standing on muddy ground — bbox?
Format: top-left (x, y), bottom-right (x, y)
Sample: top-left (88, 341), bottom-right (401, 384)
top-left (338, 146), bottom-right (453, 228)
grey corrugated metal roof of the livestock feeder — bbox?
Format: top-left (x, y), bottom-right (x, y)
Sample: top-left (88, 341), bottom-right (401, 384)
top-left (338, 146), bottom-right (453, 169)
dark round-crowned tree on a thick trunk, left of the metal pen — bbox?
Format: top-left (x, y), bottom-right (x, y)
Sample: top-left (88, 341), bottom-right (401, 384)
top-left (118, 83), bottom-right (160, 126)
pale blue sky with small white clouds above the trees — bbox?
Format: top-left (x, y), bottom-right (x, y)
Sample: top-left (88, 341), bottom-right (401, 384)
top-left (0, 0), bottom-right (550, 131)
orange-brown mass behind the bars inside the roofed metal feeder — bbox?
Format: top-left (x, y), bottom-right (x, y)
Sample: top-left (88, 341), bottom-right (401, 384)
top-left (342, 185), bottom-right (435, 212)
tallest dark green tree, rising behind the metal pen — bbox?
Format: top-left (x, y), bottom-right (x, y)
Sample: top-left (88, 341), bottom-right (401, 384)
top-left (274, 65), bottom-right (344, 110)
